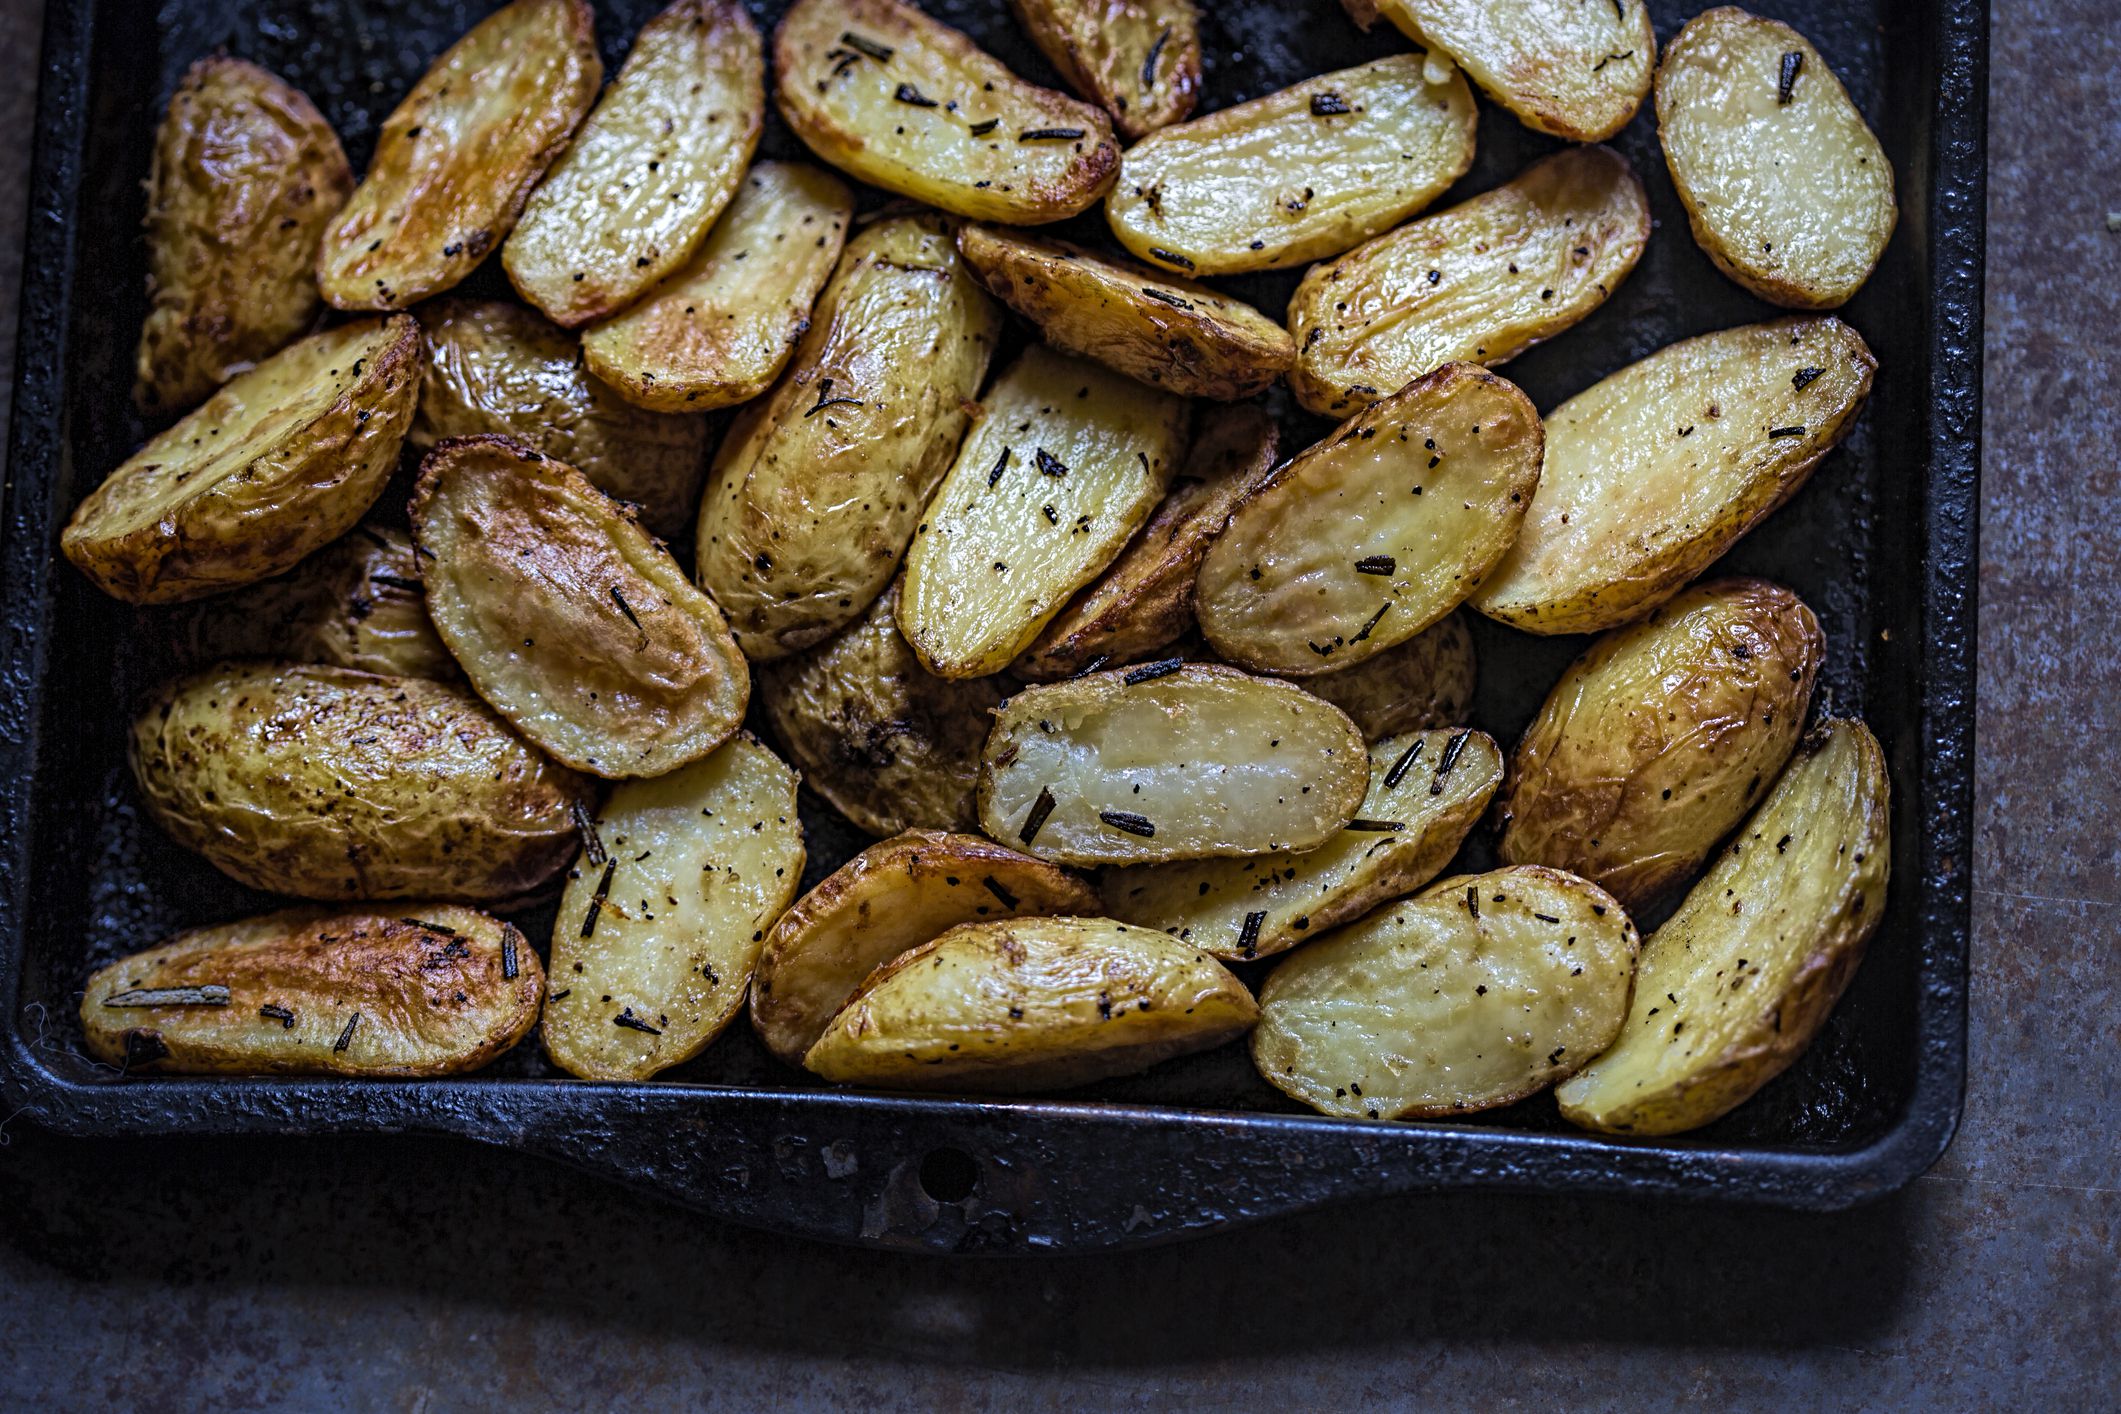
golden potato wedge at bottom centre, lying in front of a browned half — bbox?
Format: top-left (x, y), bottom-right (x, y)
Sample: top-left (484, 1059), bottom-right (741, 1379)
top-left (804, 918), bottom-right (1260, 1092)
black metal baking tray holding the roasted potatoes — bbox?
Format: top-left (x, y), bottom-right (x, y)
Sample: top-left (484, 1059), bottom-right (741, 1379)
top-left (0, 0), bottom-right (1987, 1251)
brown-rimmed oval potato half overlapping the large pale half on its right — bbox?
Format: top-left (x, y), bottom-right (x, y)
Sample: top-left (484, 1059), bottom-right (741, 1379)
top-left (1194, 363), bottom-right (1544, 676)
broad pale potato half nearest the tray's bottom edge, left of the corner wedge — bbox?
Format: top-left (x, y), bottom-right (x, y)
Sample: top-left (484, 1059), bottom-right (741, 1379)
top-left (1251, 865), bottom-right (1640, 1119)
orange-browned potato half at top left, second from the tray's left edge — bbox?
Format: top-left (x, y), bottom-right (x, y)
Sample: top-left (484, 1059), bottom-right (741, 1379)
top-left (316, 0), bottom-right (604, 310)
